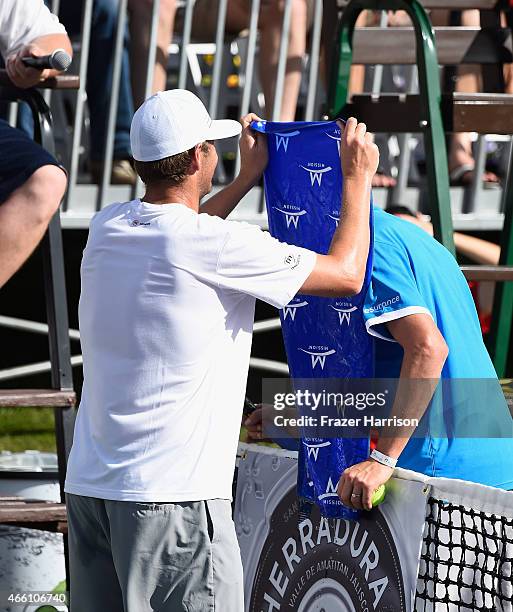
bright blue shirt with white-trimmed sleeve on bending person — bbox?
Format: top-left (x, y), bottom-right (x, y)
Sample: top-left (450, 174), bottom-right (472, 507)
top-left (363, 208), bottom-right (513, 489)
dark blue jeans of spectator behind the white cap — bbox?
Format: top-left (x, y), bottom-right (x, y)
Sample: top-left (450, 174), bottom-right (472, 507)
top-left (59, 0), bottom-right (134, 161)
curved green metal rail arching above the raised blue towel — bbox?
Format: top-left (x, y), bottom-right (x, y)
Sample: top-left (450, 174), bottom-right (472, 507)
top-left (329, 0), bottom-right (455, 255)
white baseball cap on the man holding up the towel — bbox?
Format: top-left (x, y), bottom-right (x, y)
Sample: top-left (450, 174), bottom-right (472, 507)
top-left (130, 89), bottom-right (242, 161)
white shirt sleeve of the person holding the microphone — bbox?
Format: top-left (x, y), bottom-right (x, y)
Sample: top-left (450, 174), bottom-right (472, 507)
top-left (0, 0), bottom-right (66, 57)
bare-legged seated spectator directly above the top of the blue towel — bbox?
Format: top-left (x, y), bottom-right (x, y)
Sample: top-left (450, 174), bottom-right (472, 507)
top-left (188, 0), bottom-right (313, 121)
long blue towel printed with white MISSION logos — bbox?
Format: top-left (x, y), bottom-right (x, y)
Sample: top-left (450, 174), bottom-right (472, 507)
top-left (252, 121), bottom-right (374, 518)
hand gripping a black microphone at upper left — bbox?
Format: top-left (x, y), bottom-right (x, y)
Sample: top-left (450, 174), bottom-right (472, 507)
top-left (5, 43), bottom-right (71, 89)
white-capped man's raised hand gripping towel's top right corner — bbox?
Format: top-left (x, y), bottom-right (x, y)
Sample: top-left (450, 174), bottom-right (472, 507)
top-left (339, 117), bottom-right (379, 184)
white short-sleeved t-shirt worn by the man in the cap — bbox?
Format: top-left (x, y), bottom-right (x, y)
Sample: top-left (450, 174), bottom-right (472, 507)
top-left (65, 200), bottom-right (316, 502)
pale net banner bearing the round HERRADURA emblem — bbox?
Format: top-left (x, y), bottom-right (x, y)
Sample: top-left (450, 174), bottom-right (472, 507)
top-left (234, 446), bottom-right (429, 612)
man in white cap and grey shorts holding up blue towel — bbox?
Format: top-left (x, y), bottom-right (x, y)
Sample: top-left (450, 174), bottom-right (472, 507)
top-left (65, 90), bottom-right (378, 612)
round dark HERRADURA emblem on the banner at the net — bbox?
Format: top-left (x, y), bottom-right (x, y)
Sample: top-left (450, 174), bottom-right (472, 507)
top-left (248, 488), bottom-right (406, 612)
